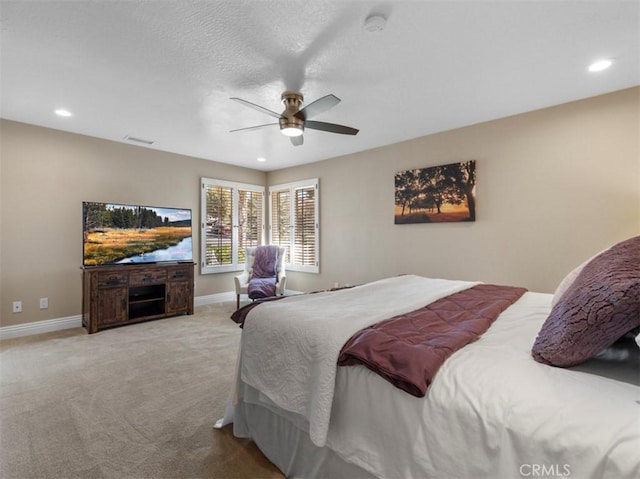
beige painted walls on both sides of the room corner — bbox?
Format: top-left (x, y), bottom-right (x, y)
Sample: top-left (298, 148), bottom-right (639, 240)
top-left (0, 88), bottom-right (640, 326)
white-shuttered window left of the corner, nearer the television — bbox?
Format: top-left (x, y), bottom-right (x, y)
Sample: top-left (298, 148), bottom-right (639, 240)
top-left (200, 178), bottom-right (264, 274)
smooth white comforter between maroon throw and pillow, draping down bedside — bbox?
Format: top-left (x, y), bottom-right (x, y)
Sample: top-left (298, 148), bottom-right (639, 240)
top-left (327, 293), bottom-right (640, 479)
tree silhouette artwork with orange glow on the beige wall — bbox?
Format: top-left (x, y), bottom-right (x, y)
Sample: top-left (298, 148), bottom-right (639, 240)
top-left (395, 160), bottom-right (476, 224)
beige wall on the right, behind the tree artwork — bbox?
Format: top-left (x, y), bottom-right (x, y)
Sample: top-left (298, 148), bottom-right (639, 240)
top-left (269, 88), bottom-right (640, 292)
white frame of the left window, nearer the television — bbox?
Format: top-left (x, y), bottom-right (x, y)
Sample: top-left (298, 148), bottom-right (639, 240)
top-left (200, 177), bottom-right (267, 274)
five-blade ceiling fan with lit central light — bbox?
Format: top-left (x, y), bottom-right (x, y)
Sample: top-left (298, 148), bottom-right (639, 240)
top-left (231, 91), bottom-right (358, 146)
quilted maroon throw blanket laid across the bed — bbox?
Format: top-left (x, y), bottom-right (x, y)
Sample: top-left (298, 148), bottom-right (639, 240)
top-left (338, 284), bottom-right (526, 397)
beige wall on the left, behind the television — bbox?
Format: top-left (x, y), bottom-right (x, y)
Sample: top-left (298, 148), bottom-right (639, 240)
top-left (0, 120), bottom-right (266, 326)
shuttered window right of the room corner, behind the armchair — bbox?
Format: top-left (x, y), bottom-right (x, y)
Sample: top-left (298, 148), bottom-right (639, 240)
top-left (269, 178), bottom-right (320, 273)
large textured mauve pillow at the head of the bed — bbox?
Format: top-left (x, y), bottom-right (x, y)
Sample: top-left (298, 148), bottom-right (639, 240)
top-left (531, 236), bottom-right (640, 367)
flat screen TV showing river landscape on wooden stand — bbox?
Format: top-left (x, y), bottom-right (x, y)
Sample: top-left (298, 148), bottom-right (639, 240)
top-left (82, 201), bottom-right (193, 266)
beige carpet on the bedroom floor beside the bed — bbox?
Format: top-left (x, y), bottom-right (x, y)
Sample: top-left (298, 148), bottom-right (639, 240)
top-left (0, 302), bottom-right (283, 479)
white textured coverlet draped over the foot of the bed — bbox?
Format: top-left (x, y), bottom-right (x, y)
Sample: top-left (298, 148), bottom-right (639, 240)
top-left (240, 275), bottom-right (477, 446)
